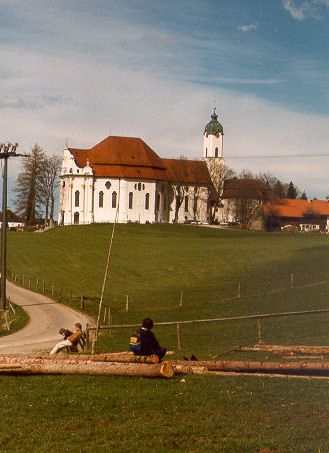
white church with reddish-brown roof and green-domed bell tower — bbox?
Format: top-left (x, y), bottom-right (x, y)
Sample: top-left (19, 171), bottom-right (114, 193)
top-left (59, 109), bottom-right (224, 225)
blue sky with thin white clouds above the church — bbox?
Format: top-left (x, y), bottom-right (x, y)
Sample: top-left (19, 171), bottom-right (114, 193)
top-left (0, 0), bottom-right (329, 201)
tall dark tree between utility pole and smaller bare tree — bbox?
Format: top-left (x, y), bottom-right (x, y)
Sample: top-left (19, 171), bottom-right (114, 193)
top-left (14, 143), bottom-right (45, 225)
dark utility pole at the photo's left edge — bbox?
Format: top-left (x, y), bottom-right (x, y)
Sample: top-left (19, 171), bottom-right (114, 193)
top-left (0, 142), bottom-right (26, 310)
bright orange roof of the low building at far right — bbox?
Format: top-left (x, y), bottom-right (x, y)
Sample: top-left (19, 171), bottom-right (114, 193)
top-left (264, 198), bottom-right (329, 218)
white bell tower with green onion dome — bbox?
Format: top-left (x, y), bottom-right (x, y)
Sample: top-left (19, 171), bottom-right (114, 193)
top-left (203, 107), bottom-right (224, 160)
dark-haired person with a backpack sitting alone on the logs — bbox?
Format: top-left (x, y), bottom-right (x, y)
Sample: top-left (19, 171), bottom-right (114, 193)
top-left (129, 318), bottom-right (167, 361)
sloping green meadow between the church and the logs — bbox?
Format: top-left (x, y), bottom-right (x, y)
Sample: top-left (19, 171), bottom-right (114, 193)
top-left (8, 225), bottom-right (329, 355)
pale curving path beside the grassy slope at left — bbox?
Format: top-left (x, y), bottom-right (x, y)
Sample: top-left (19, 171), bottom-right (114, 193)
top-left (0, 282), bottom-right (93, 354)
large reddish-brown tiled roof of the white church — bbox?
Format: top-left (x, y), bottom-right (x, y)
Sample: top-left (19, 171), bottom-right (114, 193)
top-left (69, 136), bottom-right (211, 184)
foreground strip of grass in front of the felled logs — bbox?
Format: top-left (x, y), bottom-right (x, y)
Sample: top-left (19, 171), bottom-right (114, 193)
top-left (0, 370), bottom-right (329, 453)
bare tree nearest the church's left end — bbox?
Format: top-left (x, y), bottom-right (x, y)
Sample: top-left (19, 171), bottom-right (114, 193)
top-left (42, 154), bottom-right (62, 224)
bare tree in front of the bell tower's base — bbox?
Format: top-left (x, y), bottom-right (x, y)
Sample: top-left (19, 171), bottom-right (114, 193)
top-left (207, 159), bottom-right (235, 223)
